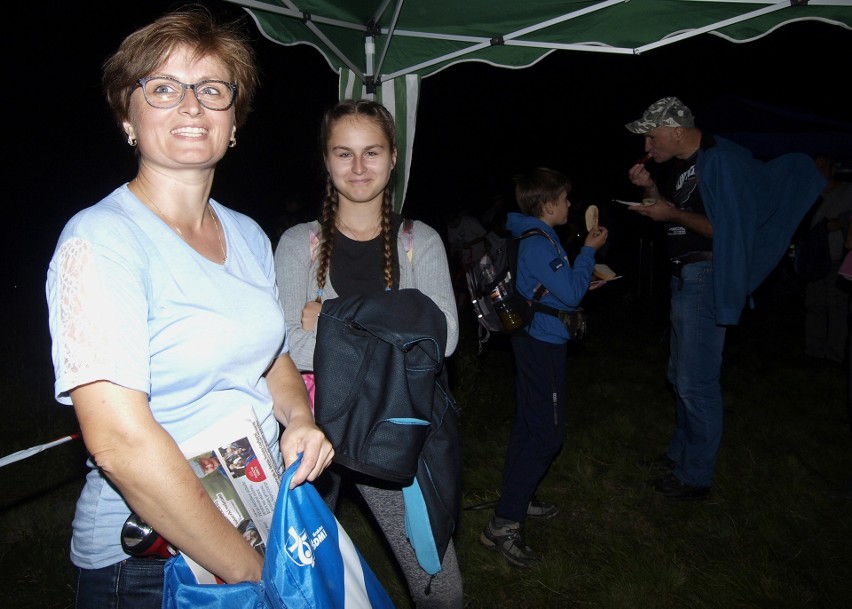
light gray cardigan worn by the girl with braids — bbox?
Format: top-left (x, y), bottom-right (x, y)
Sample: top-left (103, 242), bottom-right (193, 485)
top-left (275, 220), bottom-right (459, 371)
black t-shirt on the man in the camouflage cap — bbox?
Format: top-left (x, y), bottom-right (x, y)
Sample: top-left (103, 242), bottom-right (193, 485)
top-left (660, 133), bottom-right (716, 258)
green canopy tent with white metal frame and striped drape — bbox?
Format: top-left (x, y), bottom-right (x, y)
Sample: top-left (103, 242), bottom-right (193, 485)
top-left (227, 0), bottom-right (852, 210)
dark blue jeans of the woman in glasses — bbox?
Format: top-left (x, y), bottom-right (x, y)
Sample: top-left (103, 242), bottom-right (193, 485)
top-left (77, 558), bottom-right (166, 609)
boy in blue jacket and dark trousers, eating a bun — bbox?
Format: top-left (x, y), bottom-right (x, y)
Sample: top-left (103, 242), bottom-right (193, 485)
top-left (479, 168), bottom-right (608, 568)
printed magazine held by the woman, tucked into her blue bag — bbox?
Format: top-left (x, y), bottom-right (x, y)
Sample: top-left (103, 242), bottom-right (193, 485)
top-left (180, 406), bottom-right (281, 584)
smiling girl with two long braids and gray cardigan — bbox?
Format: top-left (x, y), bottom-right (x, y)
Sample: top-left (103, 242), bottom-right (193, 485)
top-left (275, 100), bottom-right (463, 609)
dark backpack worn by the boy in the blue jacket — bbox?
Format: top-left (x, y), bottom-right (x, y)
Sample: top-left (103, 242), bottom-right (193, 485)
top-left (465, 228), bottom-right (585, 352)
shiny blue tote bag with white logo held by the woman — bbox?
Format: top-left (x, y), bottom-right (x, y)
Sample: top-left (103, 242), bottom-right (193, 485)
top-left (163, 459), bottom-right (394, 609)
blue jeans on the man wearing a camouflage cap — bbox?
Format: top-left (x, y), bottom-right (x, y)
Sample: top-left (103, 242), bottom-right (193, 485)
top-left (667, 260), bottom-right (725, 486)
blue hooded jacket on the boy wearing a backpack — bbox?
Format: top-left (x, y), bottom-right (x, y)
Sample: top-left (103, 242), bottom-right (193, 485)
top-left (506, 212), bottom-right (595, 344)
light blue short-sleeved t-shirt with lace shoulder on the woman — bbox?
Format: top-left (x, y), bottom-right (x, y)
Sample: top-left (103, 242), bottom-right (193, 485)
top-left (46, 185), bottom-right (288, 569)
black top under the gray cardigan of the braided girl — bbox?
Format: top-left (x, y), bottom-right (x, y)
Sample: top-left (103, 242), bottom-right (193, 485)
top-left (329, 214), bottom-right (402, 298)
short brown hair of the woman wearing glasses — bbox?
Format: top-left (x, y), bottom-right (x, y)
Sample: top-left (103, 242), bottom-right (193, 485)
top-left (101, 6), bottom-right (258, 127)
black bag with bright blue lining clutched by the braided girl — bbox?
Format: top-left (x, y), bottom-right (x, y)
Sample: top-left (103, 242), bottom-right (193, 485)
top-left (314, 289), bottom-right (461, 575)
